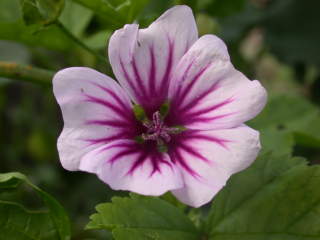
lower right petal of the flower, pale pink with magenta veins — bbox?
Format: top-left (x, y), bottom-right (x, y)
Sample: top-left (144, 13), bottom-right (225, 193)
top-left (169, 125), bottom-right (260, 207)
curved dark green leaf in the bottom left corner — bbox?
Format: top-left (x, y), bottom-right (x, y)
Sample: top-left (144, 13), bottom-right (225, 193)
top-left (0, 172), bottom-right (71, 240)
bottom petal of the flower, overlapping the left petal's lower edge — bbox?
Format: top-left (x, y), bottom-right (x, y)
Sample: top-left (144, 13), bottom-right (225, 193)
top-left (80, 140), bottom-right (183, 196)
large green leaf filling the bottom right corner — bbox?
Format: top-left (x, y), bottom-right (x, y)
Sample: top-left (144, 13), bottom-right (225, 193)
top-left (206, 153), bottom-right (320, 240)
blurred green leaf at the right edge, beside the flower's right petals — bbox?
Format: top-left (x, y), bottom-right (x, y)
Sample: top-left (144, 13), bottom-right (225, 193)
top-left (249, 95), bottom-right (320, 147)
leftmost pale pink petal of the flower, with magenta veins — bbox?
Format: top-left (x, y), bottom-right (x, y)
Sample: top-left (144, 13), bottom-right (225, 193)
top-left (53, 67), bottom-right (135, 171)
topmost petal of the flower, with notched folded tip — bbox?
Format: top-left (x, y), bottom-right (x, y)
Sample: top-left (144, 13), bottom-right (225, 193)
top-left (109, 6), bottom-right (198, 114)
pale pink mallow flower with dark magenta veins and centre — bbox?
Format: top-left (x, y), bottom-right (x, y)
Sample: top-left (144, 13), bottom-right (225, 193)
top-left (53, 6), bottom-right (266, 207)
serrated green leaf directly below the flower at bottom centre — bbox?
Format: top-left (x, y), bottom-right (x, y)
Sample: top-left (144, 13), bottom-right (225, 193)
top-left (86, 195), bottom-right (200, 240)
